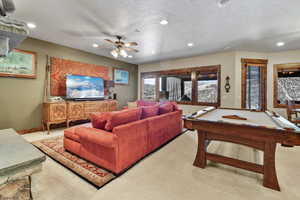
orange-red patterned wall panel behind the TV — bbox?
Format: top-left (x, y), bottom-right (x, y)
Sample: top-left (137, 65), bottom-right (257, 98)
top-left (50, 57), bottom-right (110, 96)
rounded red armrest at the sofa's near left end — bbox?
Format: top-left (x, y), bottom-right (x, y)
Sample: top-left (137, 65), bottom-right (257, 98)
top-left (75, 127), bottom-right (116, 148)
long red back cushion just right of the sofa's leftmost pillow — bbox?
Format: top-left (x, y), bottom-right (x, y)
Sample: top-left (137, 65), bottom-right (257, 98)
top-left (105, 108), bottom-right (142, 131)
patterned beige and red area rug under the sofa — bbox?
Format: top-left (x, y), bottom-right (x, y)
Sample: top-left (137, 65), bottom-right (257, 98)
top-left (32, 136), bottom-right (116, 187)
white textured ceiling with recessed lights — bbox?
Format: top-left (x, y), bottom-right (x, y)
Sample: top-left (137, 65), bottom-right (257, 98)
top-left (12, 0), bottom-right (300, 64)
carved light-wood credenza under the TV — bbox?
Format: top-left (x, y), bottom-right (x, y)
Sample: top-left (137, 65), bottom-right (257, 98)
top-left (42, 100), bottom-right (118, 134)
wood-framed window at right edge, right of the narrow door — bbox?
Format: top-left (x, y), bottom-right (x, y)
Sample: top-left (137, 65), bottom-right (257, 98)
top-left (274, 63), bottom-right (300, 107)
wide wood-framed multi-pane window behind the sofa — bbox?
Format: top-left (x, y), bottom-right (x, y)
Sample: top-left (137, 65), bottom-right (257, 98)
top-left (141, 66), bottom-right (220, 106)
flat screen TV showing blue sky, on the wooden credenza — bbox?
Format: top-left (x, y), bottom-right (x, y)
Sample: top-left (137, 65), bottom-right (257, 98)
top-left (66, 75), bottom-right (104, 100)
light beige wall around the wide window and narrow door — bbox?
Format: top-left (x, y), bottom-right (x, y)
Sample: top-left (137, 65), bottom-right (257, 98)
top-left (138, 50), bottom-right (300, 116)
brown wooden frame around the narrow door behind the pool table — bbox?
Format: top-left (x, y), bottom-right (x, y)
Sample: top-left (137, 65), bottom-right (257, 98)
top-left (241, 58), bottom-right (268, 111)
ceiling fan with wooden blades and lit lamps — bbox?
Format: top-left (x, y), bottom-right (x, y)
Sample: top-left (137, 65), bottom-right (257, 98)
top-left (104, 35), bottom-right (139, 58)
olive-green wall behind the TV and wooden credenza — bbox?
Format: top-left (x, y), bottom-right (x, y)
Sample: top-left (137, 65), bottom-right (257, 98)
top-left (0, 38), bottom-right (138, 130)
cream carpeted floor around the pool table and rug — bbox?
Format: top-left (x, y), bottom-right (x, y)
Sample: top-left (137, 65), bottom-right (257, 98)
top-left (24, 130), bottom-right (300, 200)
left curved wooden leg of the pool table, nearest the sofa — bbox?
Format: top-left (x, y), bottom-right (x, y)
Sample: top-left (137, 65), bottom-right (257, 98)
top-left (194, 130), bottom-right (206, 168)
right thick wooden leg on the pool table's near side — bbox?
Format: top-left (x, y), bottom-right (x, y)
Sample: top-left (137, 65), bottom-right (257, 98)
top-left (263, 142), bottom-right (280, 191)
